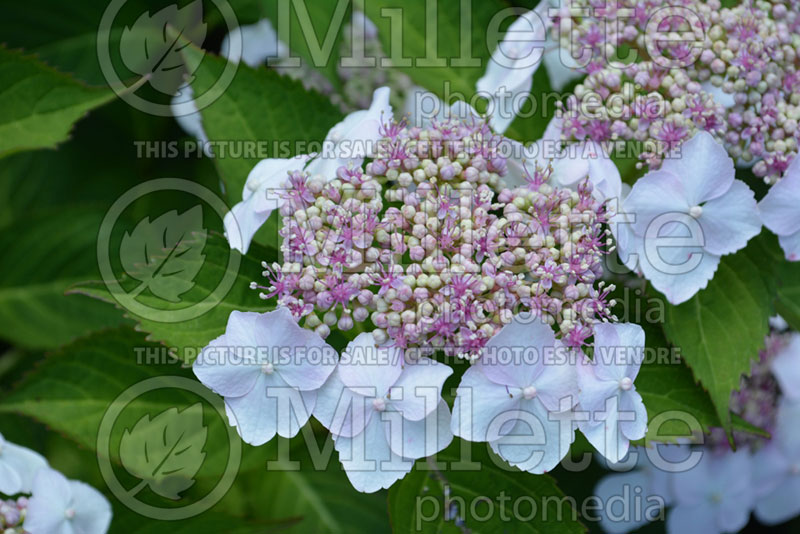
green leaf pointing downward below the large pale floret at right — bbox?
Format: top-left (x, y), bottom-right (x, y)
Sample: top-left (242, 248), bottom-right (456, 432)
top-left (665, 238), bottom-right (774, 431)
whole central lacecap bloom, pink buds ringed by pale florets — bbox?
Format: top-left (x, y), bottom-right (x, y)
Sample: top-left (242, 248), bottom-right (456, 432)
top-left (194, 89), bottom-right (647, 492)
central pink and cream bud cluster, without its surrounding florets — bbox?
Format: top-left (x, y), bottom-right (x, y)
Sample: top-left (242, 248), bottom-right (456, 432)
top-left (252, 117), bottom-right (614, 357)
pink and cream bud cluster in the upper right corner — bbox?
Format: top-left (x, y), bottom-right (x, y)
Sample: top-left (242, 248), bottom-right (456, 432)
top-left (554, 0), bottom-right (800, 183)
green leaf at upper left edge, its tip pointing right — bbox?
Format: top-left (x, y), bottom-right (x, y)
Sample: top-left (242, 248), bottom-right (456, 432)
top-left (0, 47), bottom-right (114, 156)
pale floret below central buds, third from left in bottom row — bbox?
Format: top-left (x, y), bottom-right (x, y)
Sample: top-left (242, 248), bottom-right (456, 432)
top-left (451, 317), bottom-right (578, 474)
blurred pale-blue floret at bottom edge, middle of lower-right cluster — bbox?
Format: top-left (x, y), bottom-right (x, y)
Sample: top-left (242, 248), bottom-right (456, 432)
top-left (667, 451), bottom-right (757, 534)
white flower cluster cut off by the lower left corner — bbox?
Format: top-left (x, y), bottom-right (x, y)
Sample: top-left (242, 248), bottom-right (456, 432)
top-left (0, 434), bottom-right (111, 534)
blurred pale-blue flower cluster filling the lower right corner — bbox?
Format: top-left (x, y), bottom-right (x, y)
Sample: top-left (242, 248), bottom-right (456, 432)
top-left (595, 326), bottom-right (800, 534)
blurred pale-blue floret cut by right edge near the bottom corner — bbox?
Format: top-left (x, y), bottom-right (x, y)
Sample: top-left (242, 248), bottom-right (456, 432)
top-left (753, 400), bottom-right (800, 525)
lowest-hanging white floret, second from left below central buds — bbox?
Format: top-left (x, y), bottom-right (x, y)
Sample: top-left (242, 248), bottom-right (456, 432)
top-left (314, 333), bottom-right (453, 493)
